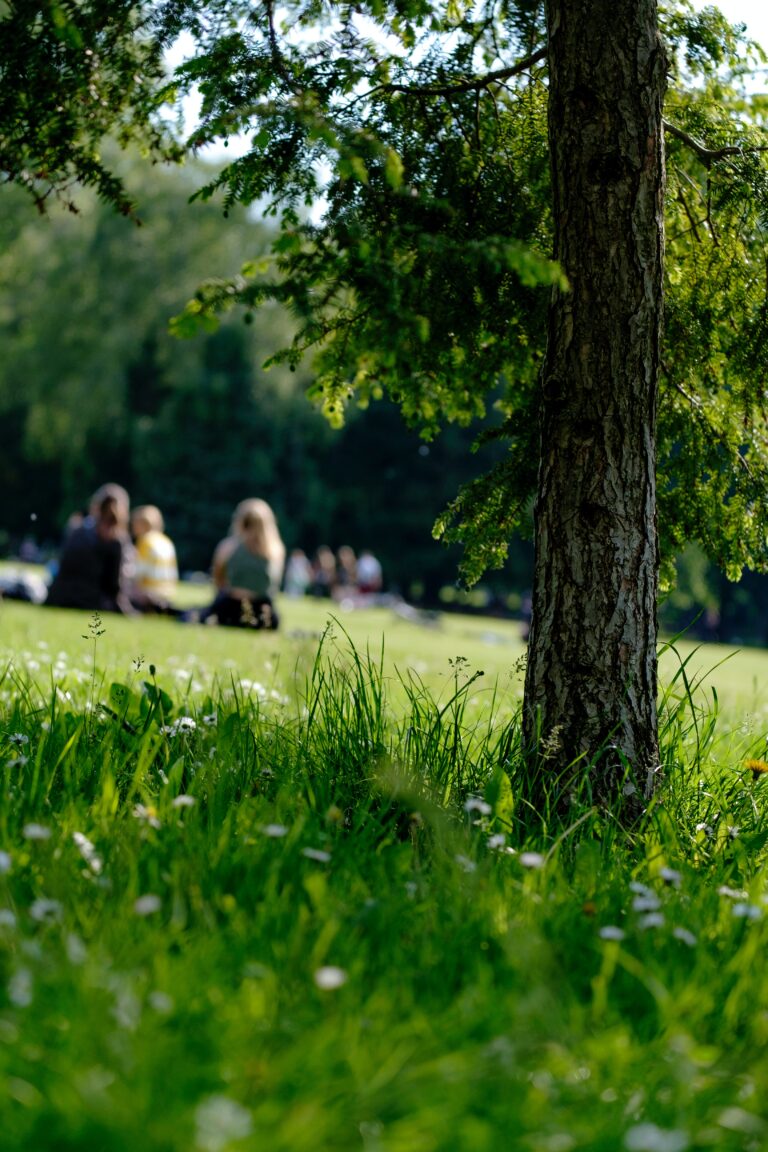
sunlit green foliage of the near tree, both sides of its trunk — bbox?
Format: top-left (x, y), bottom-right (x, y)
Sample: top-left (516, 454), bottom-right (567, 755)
top-left (158, 2), bottom-right (768, 581)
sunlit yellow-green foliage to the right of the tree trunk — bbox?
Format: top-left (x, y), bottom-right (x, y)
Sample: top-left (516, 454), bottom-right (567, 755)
top-left (659, 2), bottom-right (768, 579)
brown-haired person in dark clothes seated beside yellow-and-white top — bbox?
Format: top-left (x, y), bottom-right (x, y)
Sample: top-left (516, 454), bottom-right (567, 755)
top-left (45, 484), bottom-right (134, 615)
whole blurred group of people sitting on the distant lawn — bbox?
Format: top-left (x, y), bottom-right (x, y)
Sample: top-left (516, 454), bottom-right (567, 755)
top-left (21, 484), bottom-right (383, 629)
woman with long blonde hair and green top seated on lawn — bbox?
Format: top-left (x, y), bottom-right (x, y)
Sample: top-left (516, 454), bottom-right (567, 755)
top-left (200, 498), bottom-right (286, 628)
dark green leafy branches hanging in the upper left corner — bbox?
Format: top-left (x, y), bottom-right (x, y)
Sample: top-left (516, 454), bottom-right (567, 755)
top-left (0, 0), bottom-right (181, 214)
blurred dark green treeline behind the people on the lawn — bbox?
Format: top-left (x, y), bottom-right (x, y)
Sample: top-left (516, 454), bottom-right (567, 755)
top-left (0, 157), bottom-right (531, 605)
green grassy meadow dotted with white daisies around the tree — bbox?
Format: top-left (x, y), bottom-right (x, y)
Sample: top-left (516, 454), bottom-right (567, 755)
top-left (0, 592), bottom-right (768, 1152)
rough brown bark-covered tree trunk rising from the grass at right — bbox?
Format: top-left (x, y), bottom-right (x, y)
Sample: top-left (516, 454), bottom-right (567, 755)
top-left (525, 0), bottom-right (667, 810)
